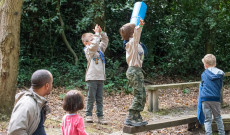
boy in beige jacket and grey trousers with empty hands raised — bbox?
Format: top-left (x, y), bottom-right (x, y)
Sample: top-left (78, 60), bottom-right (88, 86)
top-left (81, 25), bottom-right (109, 124)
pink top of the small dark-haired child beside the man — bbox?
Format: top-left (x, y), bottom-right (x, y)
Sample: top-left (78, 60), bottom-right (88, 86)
top-left (62, 114), bottom-right (87, 135)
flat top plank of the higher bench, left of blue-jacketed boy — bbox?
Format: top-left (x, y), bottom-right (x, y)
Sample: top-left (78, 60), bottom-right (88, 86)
top-left (146, 81), bottom-right (200, 91)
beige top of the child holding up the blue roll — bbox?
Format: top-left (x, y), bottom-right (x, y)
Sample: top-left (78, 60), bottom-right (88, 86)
top-left (125, 26), bottom-right (144, 67)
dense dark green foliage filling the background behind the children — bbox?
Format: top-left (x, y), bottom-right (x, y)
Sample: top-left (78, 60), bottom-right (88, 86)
top-left (18, 0), bottom-right (230, 92)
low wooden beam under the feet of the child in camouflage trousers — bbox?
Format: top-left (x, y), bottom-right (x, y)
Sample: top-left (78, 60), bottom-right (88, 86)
top-left (123, 115), bottom-right (197, 134)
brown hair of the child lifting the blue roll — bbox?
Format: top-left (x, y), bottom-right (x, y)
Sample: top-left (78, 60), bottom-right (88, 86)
top-left (119, 23), bottom-right (136, 40)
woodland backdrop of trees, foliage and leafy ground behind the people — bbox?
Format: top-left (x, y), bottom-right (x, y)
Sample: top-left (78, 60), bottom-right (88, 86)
top-left (0, 0), bottom-right (230, 134)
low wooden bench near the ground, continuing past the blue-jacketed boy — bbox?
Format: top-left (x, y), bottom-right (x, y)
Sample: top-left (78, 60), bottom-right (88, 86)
top-left (123, 114), bottom-right (230, 134)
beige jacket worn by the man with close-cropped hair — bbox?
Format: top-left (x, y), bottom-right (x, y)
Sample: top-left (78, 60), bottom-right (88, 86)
top-left (7, 89), bottom-right (47, 135)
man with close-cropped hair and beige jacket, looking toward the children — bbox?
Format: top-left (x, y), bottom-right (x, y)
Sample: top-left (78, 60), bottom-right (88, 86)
top-left (8, 69), bottom-right (53, 135)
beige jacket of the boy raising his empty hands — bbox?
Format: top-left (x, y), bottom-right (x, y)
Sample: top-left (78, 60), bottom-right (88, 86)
top-left (84, 32), bottom-right (109, 81)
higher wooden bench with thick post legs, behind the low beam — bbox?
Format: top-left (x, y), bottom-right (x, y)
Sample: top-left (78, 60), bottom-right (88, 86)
top-left (145, 72), bottom-right (230, 112)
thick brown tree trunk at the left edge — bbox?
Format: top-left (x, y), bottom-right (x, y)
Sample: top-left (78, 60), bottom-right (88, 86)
top-left (0, 0), bottom-right (23, 116)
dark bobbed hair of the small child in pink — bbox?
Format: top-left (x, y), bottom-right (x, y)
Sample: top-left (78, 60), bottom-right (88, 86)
top-left (63, 90), bottom-right (84, 113)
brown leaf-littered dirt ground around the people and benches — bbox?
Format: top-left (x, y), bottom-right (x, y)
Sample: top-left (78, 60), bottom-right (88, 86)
top-left (0, 79), bottom-right (230, 135)
